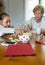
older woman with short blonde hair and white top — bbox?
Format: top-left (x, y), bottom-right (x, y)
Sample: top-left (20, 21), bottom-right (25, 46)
top-left (24, 5), bottom-right (45, 32)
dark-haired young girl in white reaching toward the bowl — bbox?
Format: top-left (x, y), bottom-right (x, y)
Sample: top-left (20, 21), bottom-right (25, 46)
top-left (0, 13), bottom-right (21, 36)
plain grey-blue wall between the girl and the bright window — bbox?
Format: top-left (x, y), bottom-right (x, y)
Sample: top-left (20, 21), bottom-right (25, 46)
top-left (3, 0), bottom-right (24, 28)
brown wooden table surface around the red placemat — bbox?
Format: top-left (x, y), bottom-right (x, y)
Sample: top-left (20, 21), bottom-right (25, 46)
top-left (0, 34), bottom-right (45, 65)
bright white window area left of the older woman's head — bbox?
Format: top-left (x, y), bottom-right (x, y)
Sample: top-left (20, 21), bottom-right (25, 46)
top-left (25, 0), bottom-right (39, 21)
